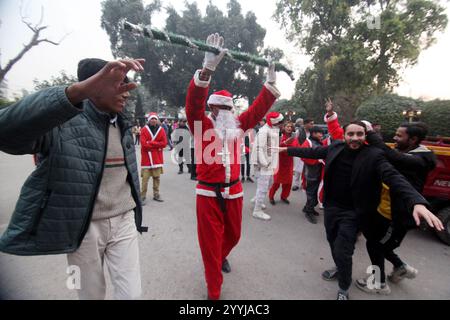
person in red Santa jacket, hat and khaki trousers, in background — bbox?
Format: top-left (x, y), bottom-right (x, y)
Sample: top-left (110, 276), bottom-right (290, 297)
top-left (141, 112), bottom-right (167, 205)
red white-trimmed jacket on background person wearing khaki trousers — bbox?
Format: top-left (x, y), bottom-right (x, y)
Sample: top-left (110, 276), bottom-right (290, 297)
top-left (141, 126), bottom-right (167, 169)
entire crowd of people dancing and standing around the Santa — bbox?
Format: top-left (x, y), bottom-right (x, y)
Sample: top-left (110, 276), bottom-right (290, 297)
top-left (0, 33), bottom-right (443, 300)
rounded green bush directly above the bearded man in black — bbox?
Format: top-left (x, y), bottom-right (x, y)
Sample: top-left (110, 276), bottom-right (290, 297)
top-left (356, 94), bottom-right (418, 140)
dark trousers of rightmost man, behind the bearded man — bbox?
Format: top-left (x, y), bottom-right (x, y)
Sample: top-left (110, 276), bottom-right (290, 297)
top-left (363, 212), bottom-right (407, 283)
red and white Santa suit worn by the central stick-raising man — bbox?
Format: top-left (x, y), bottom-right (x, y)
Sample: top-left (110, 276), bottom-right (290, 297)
top-left (186, 70), bottom-right (280, 299)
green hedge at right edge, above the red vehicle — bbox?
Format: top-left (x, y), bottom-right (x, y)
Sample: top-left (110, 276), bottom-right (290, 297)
top-left (421, 100), bottom-right (450, 137)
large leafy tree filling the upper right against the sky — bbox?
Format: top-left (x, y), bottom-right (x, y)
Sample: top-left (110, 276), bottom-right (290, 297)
top-left (276, 0), bottom-right (448, 121)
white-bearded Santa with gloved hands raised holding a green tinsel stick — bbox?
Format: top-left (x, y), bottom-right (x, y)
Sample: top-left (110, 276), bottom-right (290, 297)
top-left (186, 33), bottom-right (280, 300)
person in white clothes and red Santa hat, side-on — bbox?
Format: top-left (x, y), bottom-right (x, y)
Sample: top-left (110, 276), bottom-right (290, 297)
top-left (251, 112), bottom-right (283, 221)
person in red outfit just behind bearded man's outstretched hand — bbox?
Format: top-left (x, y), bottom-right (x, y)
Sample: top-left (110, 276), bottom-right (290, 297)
top-left (269, 122), bottom-right (298, 205)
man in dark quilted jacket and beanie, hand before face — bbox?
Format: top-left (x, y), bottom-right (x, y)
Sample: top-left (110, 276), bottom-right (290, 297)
top-left (0, 59), bottom-right (146, 299)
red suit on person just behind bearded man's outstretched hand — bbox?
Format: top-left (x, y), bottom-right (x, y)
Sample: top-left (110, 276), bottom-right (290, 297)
top-left (269, 133), bottom-right (298, 200)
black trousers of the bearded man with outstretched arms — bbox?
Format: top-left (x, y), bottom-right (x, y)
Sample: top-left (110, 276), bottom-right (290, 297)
top-left (325, 207), bottom-right (360, 290)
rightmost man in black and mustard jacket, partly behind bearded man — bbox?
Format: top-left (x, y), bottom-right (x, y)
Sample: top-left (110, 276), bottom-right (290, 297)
top-left (356, 123), bottom-right (436, 294)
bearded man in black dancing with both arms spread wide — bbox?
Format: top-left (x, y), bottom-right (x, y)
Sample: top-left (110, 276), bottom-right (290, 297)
top-left (279, 122), bottom-right (443, 300)
